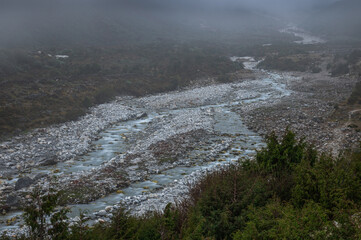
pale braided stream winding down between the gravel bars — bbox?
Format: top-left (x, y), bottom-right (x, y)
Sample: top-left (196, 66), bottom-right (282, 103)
top-left (0, 57), bottom-right (291, 231)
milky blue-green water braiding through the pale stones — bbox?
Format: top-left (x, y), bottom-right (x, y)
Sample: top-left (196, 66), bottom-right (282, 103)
top-left (0, 57), bottom-right (290, 231)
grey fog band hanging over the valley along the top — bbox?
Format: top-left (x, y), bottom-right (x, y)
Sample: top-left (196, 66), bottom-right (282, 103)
top-left (0, 0), bottom-right (360, 47)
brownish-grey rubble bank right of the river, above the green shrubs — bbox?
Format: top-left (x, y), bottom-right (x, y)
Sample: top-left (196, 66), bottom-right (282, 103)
top-left (237, 67), bottom-right (361, 155)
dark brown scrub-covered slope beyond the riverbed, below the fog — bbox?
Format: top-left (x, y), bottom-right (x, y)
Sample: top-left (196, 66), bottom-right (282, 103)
top-left (0, 42), bottom-right (242, 138)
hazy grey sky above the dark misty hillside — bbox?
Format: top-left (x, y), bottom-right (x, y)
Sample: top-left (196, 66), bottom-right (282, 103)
top-left (0, 0), bottom-right (352, 47)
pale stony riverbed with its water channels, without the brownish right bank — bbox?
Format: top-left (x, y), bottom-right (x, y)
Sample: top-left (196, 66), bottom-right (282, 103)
top-left (0, 57), bottom-right (292, 230)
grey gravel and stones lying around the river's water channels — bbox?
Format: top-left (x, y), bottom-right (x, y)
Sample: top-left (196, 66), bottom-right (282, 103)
top-left (0, 54), bottom-right (360, 236)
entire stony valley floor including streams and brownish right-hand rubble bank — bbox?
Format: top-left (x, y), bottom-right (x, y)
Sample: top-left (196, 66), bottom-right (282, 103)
top-left (0, 54), bottom-right (360, 236)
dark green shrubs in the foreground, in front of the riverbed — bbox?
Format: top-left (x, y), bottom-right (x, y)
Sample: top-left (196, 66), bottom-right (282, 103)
top-left (3, 131), bottom-right (361, 240)
